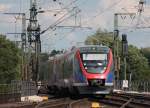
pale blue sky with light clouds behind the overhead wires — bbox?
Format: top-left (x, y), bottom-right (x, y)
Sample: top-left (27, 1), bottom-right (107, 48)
top-left (0, 0), bottom-right (150, 51)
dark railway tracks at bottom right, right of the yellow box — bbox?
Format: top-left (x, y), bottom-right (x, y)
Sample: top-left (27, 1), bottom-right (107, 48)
top-left (100, 94), bottom-right (150, 108)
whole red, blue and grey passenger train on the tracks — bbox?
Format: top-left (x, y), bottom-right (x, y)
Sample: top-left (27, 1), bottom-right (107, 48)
top-left (48, 45), bottom-right (114, 94)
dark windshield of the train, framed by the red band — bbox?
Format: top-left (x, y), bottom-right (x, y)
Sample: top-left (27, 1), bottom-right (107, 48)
top-left (82, 54), bottom-right (108, 73)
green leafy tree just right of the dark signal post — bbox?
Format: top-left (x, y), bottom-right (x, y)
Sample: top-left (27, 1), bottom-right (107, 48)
top-left (127, 45), bottom-right (150, 80)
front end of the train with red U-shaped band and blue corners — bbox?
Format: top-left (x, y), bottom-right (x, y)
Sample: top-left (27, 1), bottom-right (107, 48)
top-left (74, 46), bottom-right (114, 94)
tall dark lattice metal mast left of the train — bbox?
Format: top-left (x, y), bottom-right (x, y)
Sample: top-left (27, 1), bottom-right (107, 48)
top-left (27, 0), bottom-right (41, 82)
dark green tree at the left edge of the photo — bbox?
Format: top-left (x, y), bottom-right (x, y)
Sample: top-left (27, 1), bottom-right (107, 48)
top-left (0, 35), bottom-right (20, 83)
